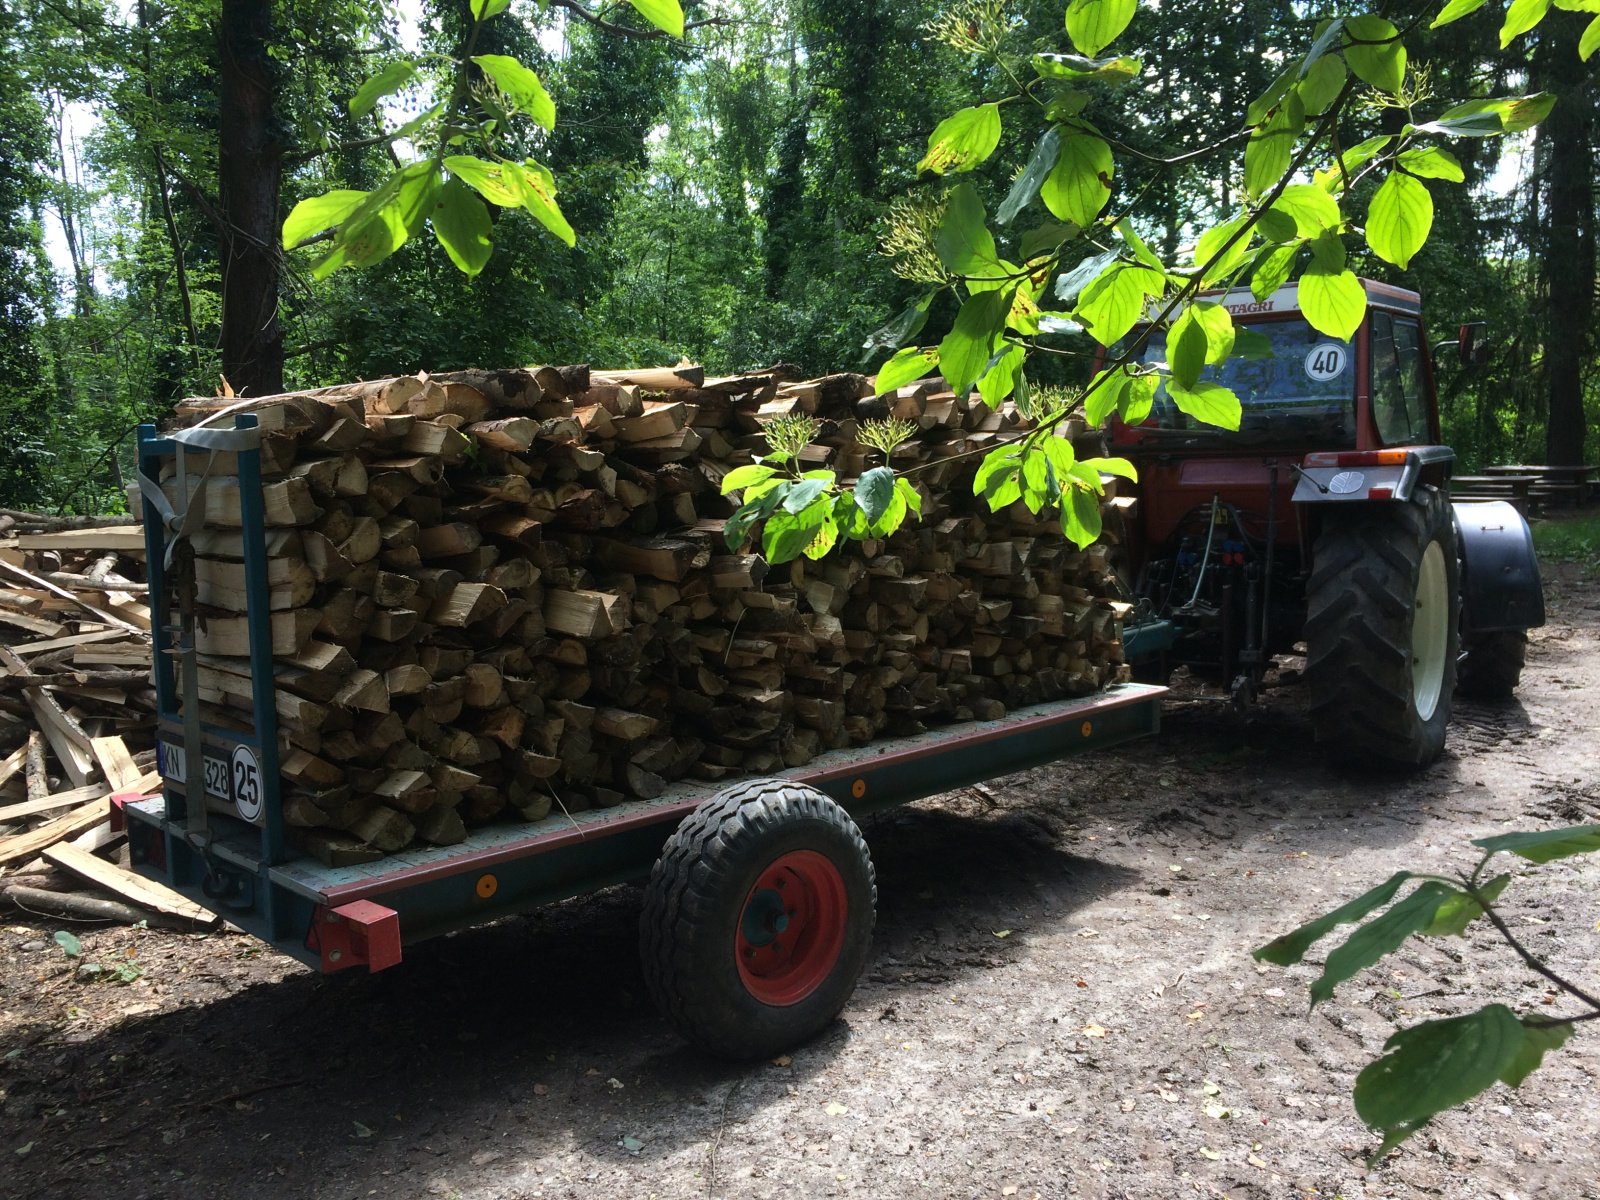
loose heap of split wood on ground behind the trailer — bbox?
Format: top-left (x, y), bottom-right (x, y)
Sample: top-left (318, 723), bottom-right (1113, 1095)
top-left (0, 510), bottom-right (210, 925)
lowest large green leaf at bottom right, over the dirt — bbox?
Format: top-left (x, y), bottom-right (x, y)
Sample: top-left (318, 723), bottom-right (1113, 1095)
top-left (1354, 1005), bottom-right (1525, 1152)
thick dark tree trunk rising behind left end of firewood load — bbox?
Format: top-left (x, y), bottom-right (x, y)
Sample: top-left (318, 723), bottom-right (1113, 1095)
top-left (218, 0), bottom-right (283, 395)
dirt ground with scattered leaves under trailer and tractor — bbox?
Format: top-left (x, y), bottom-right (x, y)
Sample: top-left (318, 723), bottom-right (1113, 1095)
top-left (0, 568), bottom-right (1600, 1200)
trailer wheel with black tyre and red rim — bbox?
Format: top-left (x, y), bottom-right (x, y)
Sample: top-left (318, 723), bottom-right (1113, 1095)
top-left (640, 779), bottom-right (878, 1059)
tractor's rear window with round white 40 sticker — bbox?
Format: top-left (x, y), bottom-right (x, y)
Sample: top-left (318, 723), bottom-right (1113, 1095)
top-left (1139, 318), bottom-right (1355, 450)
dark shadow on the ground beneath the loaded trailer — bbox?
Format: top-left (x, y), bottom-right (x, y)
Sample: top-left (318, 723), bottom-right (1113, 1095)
top-left (0, 808), bottom-right (1134, 1200)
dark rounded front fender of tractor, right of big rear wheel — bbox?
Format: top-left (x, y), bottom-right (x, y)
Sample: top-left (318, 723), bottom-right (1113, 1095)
top-left (1451, 501), bottom-right (1544, 634)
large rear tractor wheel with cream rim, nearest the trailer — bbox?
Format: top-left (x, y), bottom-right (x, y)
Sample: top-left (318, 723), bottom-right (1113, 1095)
top-left (1306, 488), bottom-right (1461, 770)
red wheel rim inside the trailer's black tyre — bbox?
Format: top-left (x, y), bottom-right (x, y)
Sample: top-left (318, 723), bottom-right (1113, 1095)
top-left (733, 850), bottom-right (850, 1006)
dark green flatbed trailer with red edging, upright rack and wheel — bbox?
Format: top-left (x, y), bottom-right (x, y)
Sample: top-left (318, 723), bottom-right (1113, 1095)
top-left (128, 416), bottom-right (1166, 1058)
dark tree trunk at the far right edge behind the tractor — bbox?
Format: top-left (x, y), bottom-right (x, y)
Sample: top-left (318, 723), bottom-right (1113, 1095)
top-left (1534, 22), bottom-right (1595, 466)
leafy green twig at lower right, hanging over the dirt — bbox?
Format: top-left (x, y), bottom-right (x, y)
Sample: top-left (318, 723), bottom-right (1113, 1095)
top-left (1254, 826), bottom-right (1600, 1166)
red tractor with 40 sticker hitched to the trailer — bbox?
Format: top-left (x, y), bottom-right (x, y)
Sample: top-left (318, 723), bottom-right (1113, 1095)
top-left (1110, 280), bottom-right (1544, 768)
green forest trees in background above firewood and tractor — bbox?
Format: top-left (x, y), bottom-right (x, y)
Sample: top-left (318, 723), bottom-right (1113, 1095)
top-left (0, 0), bottom-right (1600, 510)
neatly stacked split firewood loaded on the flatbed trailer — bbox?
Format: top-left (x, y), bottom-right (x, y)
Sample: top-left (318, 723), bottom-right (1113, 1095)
top-left (165, 366), bottom-right (1125, 864)
